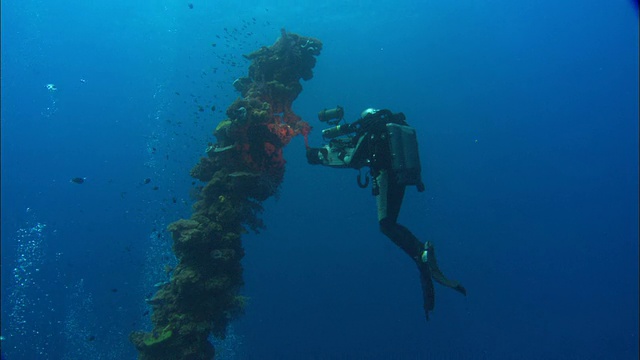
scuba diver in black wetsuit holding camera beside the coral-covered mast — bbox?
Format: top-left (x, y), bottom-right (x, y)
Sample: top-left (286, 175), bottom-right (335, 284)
top-left (307, 106), bottom-right (467, 320)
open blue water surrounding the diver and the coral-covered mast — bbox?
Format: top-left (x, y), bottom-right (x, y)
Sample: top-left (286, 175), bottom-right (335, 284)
top-left (1, 0), bottom-right (638, 359)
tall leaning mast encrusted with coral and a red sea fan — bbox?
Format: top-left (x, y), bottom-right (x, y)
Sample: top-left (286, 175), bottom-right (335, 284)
top-left (130, 30), bottom-right (322, 360)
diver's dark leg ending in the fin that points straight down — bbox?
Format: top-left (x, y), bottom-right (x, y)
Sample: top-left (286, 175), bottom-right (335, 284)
top-left (376, 171), bottom-right (435, 320)
